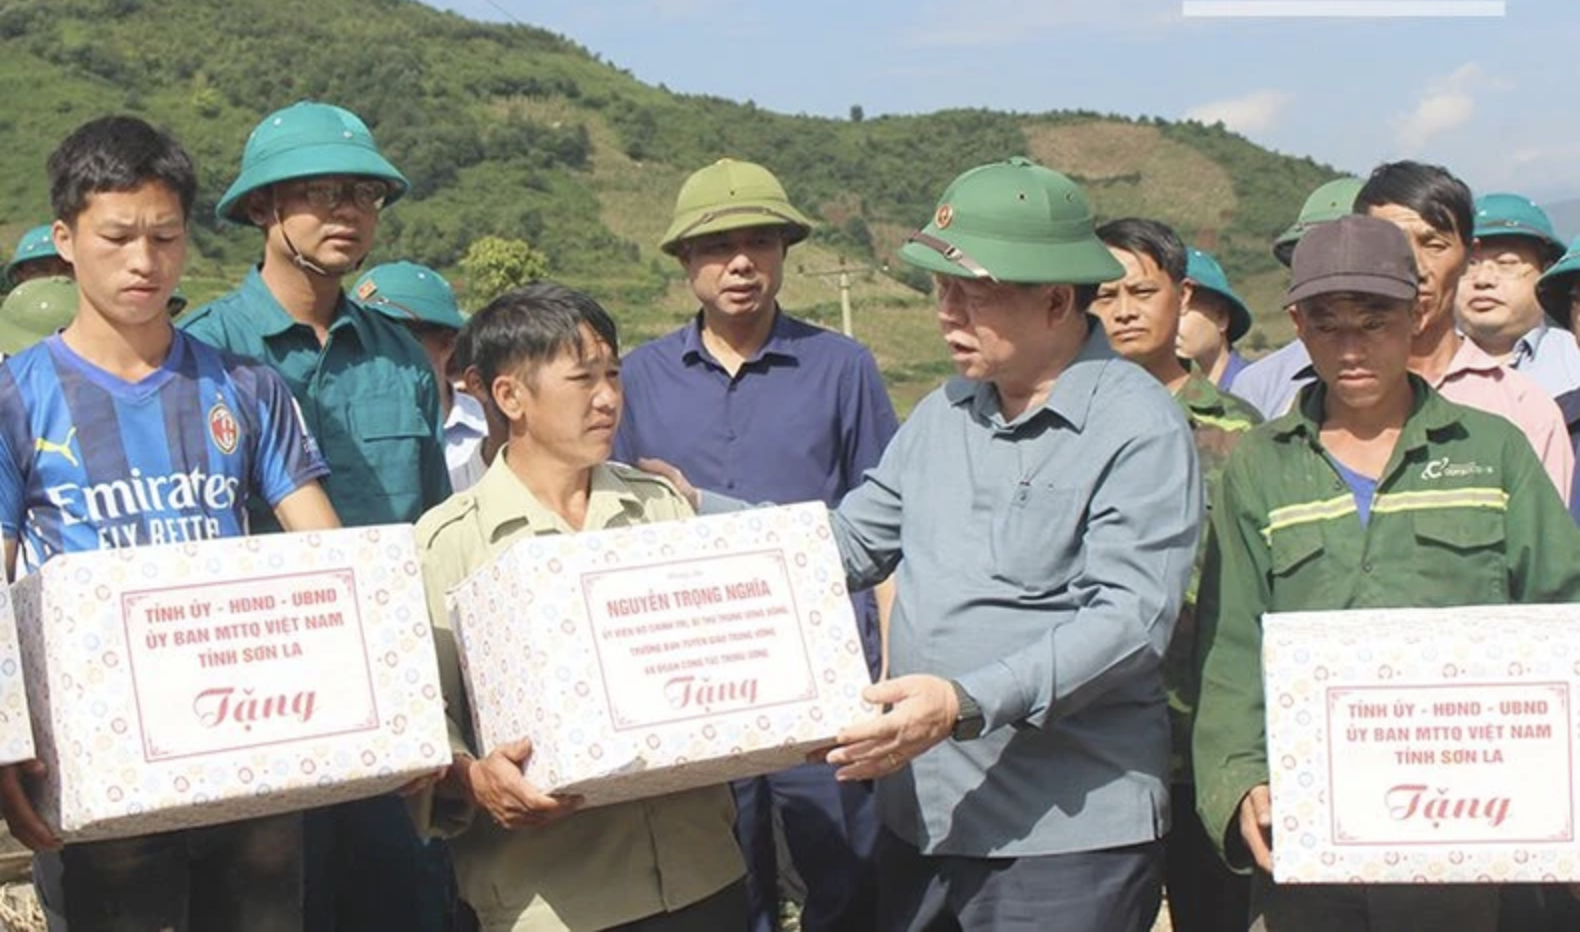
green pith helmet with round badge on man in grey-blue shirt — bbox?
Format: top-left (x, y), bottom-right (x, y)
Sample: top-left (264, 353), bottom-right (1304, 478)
top-left (899, 158), bottom-right (1125, 284)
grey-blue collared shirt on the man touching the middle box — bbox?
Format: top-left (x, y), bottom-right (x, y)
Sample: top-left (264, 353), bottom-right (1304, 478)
top-left (833, 329), bottom-right (1201, 856)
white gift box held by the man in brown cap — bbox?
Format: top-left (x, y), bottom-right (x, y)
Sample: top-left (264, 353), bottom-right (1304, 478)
top-left (1262, 605), bottom-right (1580, 883)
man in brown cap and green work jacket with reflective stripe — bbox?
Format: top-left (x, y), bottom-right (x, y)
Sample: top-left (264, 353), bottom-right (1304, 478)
top-left (1193, 216), bottom-right (1580, 932)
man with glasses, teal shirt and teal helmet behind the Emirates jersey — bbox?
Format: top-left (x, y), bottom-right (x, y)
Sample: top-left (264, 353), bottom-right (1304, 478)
top-left (180, 101), bottom-right (453, 932)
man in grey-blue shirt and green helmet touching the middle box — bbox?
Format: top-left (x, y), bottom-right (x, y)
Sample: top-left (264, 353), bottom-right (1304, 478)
top-left (802, 158), bottom-right (1201, 932)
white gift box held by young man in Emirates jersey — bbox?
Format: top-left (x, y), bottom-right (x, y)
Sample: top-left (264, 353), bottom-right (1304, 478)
top-left (13, 524), bottom-right (450, 840)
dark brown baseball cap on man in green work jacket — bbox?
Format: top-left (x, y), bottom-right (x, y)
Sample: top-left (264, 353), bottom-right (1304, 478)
top-left (1285, 213), bottom-right (1420, 305)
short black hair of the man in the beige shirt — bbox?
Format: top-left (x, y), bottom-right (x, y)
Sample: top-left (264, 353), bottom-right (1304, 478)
top-left (457, 281), bottom-right (619, 385)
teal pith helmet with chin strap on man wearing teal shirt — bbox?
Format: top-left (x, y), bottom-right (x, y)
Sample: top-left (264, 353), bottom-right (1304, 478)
top-left (213, 101), bottom-right (411, 224)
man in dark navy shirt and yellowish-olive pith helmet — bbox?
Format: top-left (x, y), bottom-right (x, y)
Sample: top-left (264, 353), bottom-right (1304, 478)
top-left (615, 160), bottom-right (899, 932)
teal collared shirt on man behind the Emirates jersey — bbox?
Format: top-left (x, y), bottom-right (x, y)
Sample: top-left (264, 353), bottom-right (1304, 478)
top-left (180, 269), bottom-right (450, 532)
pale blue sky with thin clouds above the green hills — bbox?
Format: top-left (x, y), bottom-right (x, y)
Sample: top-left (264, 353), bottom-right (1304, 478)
top-left (431, 0), bottom-right (1580, 204)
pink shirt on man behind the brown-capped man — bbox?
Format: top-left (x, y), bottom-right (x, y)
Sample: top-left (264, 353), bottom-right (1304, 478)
top-left (1433, 338), bottom-right (1575, 505)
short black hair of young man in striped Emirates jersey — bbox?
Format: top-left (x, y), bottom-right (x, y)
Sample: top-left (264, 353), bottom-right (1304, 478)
top-left (49, 117), bottom-right (198, 223)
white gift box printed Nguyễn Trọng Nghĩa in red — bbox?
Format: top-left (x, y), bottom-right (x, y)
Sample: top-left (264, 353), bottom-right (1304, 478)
top-left (449, 504), bottom-right (875, 806)
